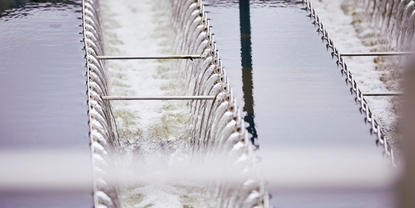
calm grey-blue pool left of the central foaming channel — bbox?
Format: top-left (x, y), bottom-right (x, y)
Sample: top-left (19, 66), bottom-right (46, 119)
top-left (0, 0), bottom-right (92, 207)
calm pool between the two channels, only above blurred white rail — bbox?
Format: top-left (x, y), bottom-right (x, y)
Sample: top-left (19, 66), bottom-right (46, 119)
top-left (208, 0), bottom-right (386, 146)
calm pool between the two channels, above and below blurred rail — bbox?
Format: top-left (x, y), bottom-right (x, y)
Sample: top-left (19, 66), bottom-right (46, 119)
top-left (206, 0), bottom-right (393, 207)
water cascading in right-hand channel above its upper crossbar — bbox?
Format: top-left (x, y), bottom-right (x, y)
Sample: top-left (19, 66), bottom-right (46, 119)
top-left (344, 0), bottom-right (415, 69)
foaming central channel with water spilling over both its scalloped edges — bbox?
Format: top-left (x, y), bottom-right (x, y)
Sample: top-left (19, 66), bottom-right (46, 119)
top-left (83, 0), bottom-right (269, 207)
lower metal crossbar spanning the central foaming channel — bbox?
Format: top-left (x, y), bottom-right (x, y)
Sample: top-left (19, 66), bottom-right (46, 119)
top-left (101, 96), bottom-right (215, 100)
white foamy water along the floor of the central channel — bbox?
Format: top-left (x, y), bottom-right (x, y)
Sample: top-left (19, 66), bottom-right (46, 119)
top-left (101, 0), bottom-right (213, 207)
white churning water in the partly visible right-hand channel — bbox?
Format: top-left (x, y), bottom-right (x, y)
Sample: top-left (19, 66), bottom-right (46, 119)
top-left (342, 0), bottom-right (414, 145)
